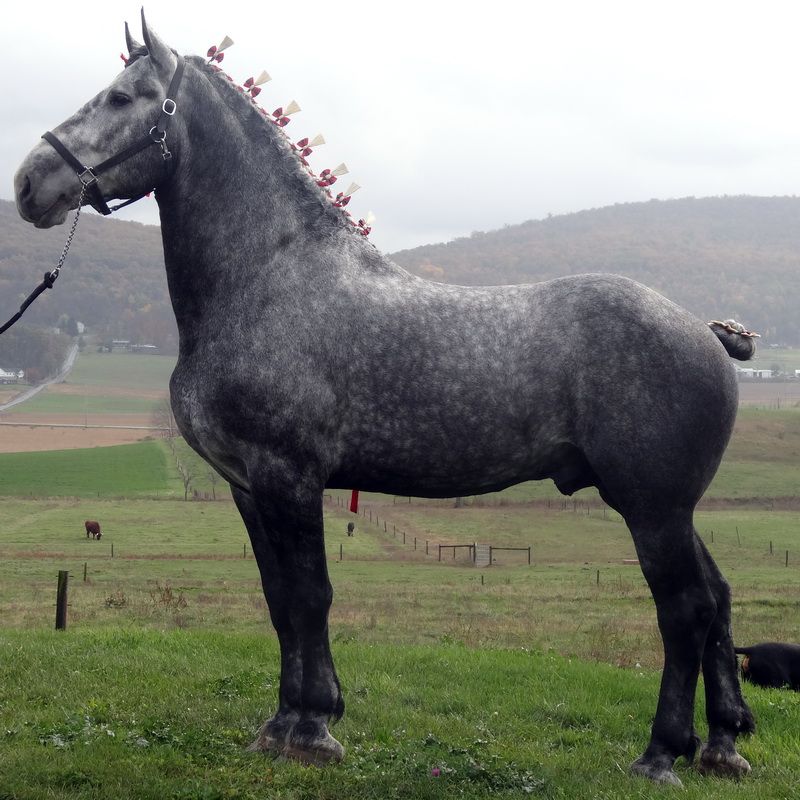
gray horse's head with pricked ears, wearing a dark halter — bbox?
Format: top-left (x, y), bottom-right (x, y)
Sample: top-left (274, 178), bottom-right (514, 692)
top-left (14, 11), bottom-right (183, 228)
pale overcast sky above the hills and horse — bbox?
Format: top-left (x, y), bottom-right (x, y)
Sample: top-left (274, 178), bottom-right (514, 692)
top-left (0, 0), bottom-right (800, 251)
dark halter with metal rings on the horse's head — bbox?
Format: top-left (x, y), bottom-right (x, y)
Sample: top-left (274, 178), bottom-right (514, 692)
top-left (42, 56), bottom-right (185, 216)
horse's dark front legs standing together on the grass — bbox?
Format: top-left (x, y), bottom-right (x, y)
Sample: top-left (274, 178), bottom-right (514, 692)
top-left (233, 487), bottom-right (344, 764)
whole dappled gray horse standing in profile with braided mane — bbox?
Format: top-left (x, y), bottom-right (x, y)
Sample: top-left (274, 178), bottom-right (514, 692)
top-left (15, 14), bottom-right (754, 783)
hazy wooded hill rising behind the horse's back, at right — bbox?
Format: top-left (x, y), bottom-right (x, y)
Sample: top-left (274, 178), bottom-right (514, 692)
top-left (392, 197), bottom-right (800, 344)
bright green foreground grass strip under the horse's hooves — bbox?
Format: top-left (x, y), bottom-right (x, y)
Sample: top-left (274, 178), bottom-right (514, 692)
top-left (0, 629), bottom-right (800, 800)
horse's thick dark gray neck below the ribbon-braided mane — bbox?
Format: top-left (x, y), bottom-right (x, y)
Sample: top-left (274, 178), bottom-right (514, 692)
top-left (156, 62), bottom-right (344, 337)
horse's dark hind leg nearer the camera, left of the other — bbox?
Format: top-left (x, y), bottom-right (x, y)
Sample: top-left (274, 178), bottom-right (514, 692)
top-left (626, 510), bottom-right (717, 785)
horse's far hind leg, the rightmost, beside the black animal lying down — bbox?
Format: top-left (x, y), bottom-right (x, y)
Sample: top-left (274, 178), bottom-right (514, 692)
top-left (695, 532), bottom-right (755, 778)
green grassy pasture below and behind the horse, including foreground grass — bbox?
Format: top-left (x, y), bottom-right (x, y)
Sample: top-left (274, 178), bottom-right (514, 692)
top-left (0, 354), bottom-right (800, 800)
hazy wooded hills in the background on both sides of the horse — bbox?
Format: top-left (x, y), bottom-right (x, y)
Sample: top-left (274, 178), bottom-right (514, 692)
top-left (0, 197), bottom-right (800, 344)
